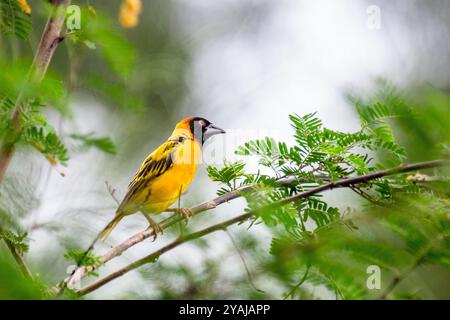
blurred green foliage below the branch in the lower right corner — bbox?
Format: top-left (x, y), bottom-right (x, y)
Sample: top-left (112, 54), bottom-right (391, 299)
top-left (271, 195), bottom-right (450, 299)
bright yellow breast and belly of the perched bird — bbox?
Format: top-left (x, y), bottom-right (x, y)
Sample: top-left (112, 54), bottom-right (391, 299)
top-left (138, 140), bottom-right (201, 213)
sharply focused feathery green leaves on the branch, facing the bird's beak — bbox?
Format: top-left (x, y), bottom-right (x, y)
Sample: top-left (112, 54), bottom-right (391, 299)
top-left (208, 104), bottom-right (413, 231)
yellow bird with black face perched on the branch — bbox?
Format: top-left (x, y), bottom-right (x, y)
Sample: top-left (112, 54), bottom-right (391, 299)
top-left (98, 117), bottom-right (225, 240)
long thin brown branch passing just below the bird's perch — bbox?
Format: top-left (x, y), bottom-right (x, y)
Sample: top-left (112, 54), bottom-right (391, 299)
top-left (73, 160), bottom-right (450, 295)
